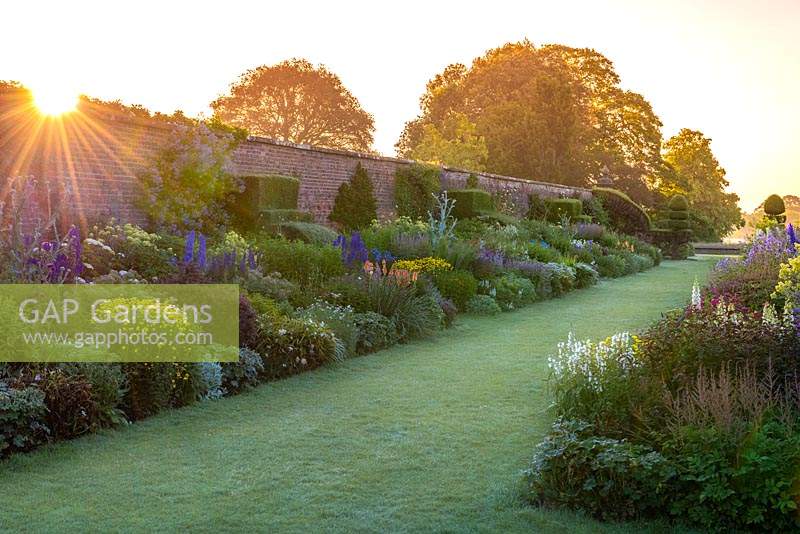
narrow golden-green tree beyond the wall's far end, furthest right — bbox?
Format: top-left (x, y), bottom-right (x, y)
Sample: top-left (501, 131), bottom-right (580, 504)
top-left (659, 128), bottom-right (743, 240)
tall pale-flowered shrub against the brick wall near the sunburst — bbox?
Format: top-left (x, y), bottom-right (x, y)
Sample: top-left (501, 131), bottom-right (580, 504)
top-left (138, 123), bottom-right (241, 233)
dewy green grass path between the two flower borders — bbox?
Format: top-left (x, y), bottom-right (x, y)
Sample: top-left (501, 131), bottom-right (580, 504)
top-left (0, 258), bottom-right (713, 533)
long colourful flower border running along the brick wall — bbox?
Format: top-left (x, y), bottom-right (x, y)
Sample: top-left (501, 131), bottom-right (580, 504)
top-left (0, 175), bottom-right (661, 456)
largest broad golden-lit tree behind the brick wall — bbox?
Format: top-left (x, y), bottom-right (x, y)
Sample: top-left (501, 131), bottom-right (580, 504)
top-left (397, 41), bottom-right (663, 196)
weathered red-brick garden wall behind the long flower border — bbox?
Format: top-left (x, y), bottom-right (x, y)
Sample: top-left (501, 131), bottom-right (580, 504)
top-left (0, 108), bottom-right (591, 227)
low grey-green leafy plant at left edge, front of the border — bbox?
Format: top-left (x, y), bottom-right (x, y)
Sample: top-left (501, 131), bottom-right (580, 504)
top-left (0, 380), bottom-right (49, 457)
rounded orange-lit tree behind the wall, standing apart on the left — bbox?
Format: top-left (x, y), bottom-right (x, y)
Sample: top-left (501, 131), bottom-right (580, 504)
top-left (211, 59), bottom-right (375, 151)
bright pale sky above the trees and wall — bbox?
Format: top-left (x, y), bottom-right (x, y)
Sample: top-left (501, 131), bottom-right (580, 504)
top-left (0, 0), bottom-right (800, 210)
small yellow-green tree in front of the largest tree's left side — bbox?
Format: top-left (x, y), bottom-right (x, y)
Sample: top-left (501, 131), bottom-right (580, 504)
top-left (409, 112), bottom-right (489, 171)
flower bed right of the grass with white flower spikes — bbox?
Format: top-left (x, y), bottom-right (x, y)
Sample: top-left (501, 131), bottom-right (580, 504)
top-left (526, 226), bottom-right (800, 531)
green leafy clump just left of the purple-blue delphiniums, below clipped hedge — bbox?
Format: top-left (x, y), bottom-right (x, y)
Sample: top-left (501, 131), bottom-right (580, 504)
top-left (257, 238), bottom-right (344, 285)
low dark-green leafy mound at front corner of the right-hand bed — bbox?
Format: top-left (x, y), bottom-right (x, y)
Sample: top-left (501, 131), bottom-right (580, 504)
top-left (525, 420), bottom-right (673, 520)
